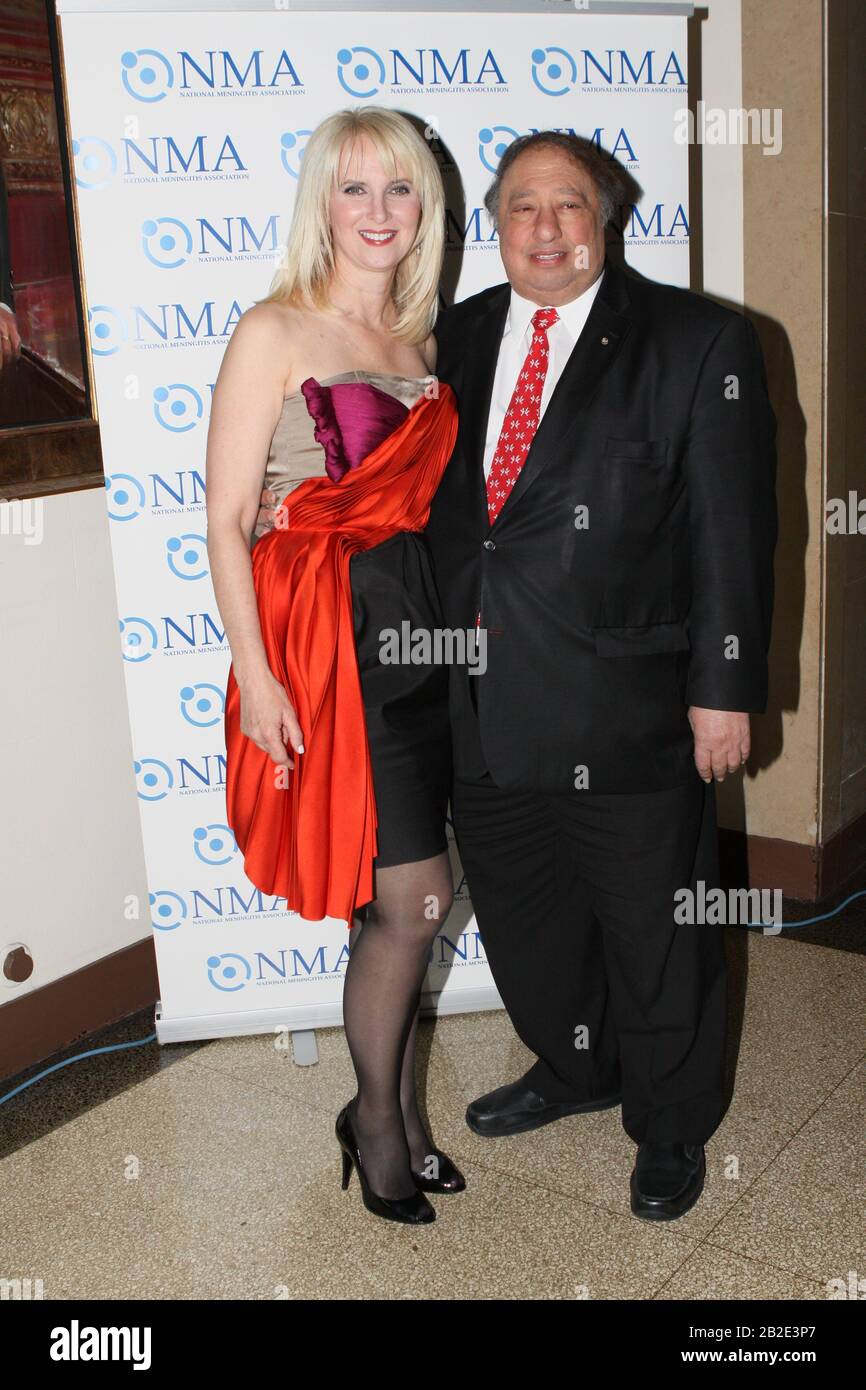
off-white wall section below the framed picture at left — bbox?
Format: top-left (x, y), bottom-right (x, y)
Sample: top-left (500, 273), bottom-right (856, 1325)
top-left (0, 489), bottom-right (152, 1005)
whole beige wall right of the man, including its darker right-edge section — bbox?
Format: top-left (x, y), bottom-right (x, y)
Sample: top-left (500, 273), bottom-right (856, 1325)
top-left (742, 0), bottom-right (866, 844)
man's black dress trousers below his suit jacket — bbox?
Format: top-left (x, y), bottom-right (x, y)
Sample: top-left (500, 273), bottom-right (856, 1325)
top-left (452, 771), bottom-right (727, 1144)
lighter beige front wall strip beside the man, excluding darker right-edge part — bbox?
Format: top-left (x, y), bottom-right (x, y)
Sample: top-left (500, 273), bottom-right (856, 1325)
top-left (727, 0), bottom-right (824, 844)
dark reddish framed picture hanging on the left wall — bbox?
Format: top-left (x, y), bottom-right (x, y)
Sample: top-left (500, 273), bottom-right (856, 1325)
top-left (0, 0), bottom-right (104, 498)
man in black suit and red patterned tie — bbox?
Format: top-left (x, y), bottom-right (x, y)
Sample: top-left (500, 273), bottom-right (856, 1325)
top-left (427, 132), bottom-right (776, 1219)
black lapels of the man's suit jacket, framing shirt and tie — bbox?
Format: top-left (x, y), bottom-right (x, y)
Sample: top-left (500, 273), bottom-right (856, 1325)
top-left (489, 260), bottom-right (631, 531)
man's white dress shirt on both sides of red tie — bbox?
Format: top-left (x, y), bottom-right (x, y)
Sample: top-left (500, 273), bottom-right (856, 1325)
top-left (484, 271), bottom-right (603, 480)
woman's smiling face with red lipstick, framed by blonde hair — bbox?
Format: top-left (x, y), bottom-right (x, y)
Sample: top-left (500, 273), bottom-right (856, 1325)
top-left (331, 136), bottom-right (421, 272)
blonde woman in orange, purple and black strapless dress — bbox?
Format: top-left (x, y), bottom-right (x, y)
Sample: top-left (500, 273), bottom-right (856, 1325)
top-left (207, 106), bottom-right (464, 1223)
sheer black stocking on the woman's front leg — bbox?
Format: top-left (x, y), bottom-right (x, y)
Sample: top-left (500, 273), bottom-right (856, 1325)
top-left (343, 853), bottom-right (453, 1197)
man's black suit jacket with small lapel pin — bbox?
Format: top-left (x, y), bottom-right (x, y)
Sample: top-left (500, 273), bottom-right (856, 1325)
top-left (425, 251), bottom-right (777, 792)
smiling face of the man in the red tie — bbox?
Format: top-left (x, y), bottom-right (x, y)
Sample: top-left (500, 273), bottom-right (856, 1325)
top-left (499, 145), bottom-right (605, 304)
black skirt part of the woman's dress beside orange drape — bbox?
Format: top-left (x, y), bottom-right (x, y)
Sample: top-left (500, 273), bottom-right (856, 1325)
top-left (349, 531), bottom-right (452, 869)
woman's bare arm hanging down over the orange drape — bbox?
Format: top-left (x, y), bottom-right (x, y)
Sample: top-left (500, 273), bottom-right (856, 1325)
top-left (207, 304), bottom-right (303, 767)
